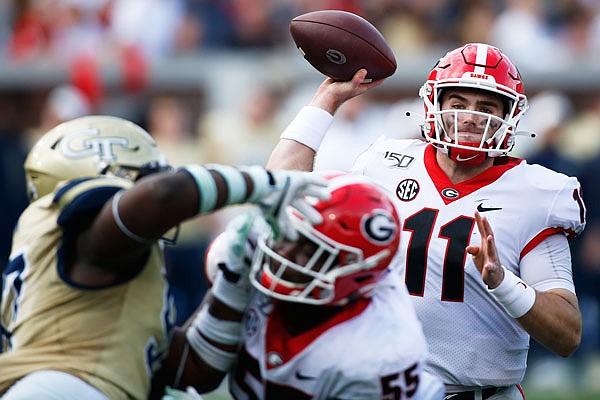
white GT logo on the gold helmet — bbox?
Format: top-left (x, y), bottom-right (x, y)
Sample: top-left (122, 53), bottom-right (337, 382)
top-left (60, 129), bottom-right (134, 162)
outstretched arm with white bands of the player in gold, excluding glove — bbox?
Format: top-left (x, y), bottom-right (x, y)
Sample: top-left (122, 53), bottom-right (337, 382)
top-left (86, 164), bottom-right (279, 260)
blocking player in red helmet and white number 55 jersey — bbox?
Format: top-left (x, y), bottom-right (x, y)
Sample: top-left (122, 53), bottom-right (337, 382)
top-left (150, 175), bottom-right (444, 400)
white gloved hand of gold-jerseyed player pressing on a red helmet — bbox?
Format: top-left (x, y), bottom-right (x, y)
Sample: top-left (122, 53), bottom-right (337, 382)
top-left (259, 170), bottom-right (331, 240)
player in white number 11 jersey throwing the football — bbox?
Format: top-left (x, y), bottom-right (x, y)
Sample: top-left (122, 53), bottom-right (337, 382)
top-left (268, 43), bottom-right (586, 400)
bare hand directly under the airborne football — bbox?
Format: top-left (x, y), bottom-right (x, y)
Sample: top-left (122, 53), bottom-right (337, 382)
top-left (309, 68), bottom-right (385, 115)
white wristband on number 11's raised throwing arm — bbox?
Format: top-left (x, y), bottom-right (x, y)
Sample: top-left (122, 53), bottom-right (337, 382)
top-left (280, 106), bottom-right (333, 151)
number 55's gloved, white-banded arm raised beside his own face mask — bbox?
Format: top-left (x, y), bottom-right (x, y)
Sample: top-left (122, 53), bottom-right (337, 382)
top-left (151, 215), bottom-right (264, 399)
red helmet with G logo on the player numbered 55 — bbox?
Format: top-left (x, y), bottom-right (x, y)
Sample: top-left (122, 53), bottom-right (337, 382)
top-left (250, 174), bottom-right (400, 305)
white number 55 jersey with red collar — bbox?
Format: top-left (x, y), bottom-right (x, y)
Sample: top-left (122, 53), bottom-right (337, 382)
top-left (229, 274), bottom-right (443, 400)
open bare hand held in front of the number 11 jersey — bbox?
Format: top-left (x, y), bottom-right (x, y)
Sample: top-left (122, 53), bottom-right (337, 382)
top-left (467, 211), bottom-right (504, 289)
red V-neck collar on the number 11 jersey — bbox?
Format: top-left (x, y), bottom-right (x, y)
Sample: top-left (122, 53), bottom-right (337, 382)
top-left (423, 144), bottom-right (523, 204)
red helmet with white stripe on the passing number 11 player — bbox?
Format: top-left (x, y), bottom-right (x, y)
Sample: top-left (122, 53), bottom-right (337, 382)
top-left (419, 43), bottom-right (528, 164)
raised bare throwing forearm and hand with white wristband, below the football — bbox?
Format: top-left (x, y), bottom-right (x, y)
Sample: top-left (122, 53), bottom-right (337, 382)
top-left (267, 69), bottom-right (384, 171)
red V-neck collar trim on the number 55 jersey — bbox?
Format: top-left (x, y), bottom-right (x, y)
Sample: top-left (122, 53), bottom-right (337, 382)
top-left (265, 298), bottom-right (371, 369)
